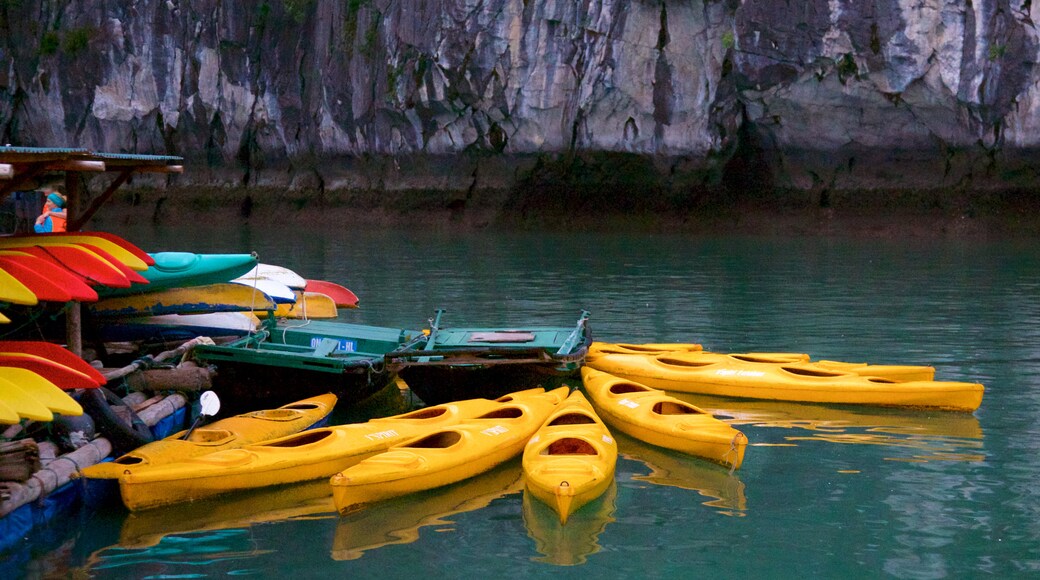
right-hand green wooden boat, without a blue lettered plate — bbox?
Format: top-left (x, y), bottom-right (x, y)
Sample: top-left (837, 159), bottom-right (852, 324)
top-left (386, 310), bottom-right (592, 404)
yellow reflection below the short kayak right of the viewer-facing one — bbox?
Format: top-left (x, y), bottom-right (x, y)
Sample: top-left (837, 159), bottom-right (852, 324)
top-left (614, 432), bottom-right (748, 517)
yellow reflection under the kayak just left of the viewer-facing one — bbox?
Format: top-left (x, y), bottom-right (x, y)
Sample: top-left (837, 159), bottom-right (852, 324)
top-left (332, 459), bottom-right (523, 560)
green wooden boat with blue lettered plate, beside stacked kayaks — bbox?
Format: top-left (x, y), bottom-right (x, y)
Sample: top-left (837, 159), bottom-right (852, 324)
top-left (192, 318), bottom-right (421, 410)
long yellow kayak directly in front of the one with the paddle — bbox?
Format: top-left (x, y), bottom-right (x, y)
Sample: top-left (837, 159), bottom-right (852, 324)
top-left (120, 391), bottom-right (561, 510)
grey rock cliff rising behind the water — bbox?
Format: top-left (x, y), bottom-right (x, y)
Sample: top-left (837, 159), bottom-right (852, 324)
top-left (0, 0), bottom-right (1040, 209)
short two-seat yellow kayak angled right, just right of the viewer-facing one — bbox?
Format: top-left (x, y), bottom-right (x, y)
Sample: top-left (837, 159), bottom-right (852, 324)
top-left (581, 367), bottom-right (748, 469)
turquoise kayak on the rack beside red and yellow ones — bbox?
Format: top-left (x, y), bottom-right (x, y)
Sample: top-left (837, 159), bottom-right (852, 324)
top-left (98, 252), bottom-right (257, 296)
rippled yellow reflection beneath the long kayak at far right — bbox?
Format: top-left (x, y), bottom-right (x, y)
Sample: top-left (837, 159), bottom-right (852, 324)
top-left (671, 393), bottom-right (986, 462)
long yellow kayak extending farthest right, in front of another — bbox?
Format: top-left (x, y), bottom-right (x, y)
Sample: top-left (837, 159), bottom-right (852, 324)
top-left (590, 352), bottom-right (984, 412)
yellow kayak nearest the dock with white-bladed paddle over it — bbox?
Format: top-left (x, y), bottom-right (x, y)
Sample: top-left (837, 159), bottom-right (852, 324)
top-left (82, 393), bottom-right (337, 479)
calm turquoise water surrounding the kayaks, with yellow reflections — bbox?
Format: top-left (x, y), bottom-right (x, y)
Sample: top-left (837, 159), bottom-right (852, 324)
top-left (8, 227), bottom-right (1040, 578)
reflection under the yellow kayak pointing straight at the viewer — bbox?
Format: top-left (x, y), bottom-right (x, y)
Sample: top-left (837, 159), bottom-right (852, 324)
top-left (523, 482), bottom-right (618, 565)
